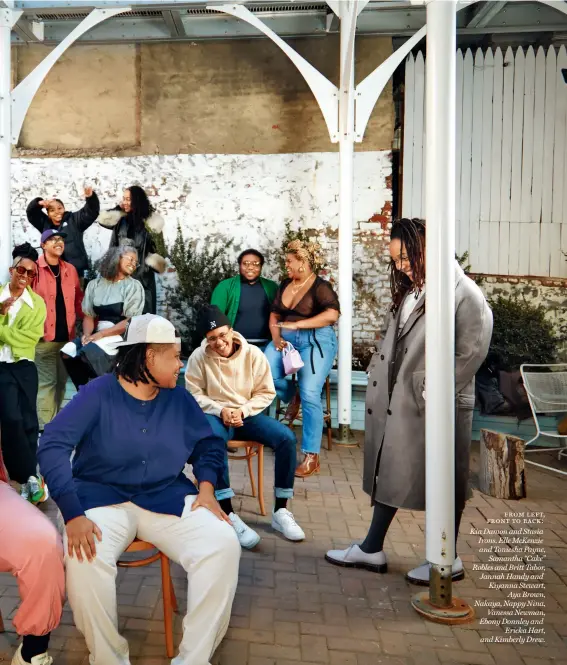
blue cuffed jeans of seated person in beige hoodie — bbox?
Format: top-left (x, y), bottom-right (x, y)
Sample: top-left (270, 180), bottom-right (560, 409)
top-left (207, 414), bottom-right (297, 501)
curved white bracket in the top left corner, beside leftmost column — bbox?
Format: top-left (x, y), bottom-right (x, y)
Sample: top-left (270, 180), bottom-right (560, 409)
top-left (11, 7), bottom-right (130, 145)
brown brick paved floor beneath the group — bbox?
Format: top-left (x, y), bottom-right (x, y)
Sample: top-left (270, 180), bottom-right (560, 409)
top-left (0, 436), bottom-right (567, 665)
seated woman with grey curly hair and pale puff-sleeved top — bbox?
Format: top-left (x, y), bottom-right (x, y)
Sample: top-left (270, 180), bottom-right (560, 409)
top-left (61, 245), bottom-right (144, 388)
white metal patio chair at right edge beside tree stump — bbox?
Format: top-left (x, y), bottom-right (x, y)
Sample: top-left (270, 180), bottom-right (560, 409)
top-left (520, 364), bottom-right (567, 475)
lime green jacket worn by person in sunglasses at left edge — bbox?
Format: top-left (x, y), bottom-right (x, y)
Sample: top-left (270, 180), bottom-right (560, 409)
top-left (0, 286), bottom-right (46, 362)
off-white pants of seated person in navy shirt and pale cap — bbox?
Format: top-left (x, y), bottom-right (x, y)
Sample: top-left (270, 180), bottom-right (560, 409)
top-left (65, 496), bottom-right (240, 665)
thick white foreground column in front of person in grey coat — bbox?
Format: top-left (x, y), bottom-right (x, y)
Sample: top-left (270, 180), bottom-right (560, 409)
top-left (425, 0), bottom-right (457, 595)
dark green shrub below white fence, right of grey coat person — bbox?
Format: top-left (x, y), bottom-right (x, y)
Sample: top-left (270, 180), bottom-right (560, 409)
top-left (486, 295), bottom-right (558, 371)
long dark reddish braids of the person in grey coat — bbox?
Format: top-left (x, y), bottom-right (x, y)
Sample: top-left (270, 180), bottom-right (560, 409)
top-left (390, 217), bottom-right (425, 314)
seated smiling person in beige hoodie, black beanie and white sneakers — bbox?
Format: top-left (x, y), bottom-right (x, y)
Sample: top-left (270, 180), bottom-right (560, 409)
top-left (185, 306), bottom-right (305, 549)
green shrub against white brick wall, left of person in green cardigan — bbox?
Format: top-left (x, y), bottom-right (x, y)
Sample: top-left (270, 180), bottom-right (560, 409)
top-left (167, 225), bottom-right (236, 356)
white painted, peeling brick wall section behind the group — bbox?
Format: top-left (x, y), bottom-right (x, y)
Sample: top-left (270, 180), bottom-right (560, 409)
top-left (12, 152), bottom-right (392, 356)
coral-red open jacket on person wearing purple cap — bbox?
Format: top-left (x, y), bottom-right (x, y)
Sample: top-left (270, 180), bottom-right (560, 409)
top-left (33, 256), bottom-right (83, 342)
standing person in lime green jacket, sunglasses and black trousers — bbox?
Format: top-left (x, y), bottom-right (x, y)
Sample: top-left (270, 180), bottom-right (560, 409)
top-left (0, 243), bottom-right (49, 503)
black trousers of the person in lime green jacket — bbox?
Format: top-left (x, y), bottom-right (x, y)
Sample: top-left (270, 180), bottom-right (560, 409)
top-left (0, 360), bottom-right (39, 483)
